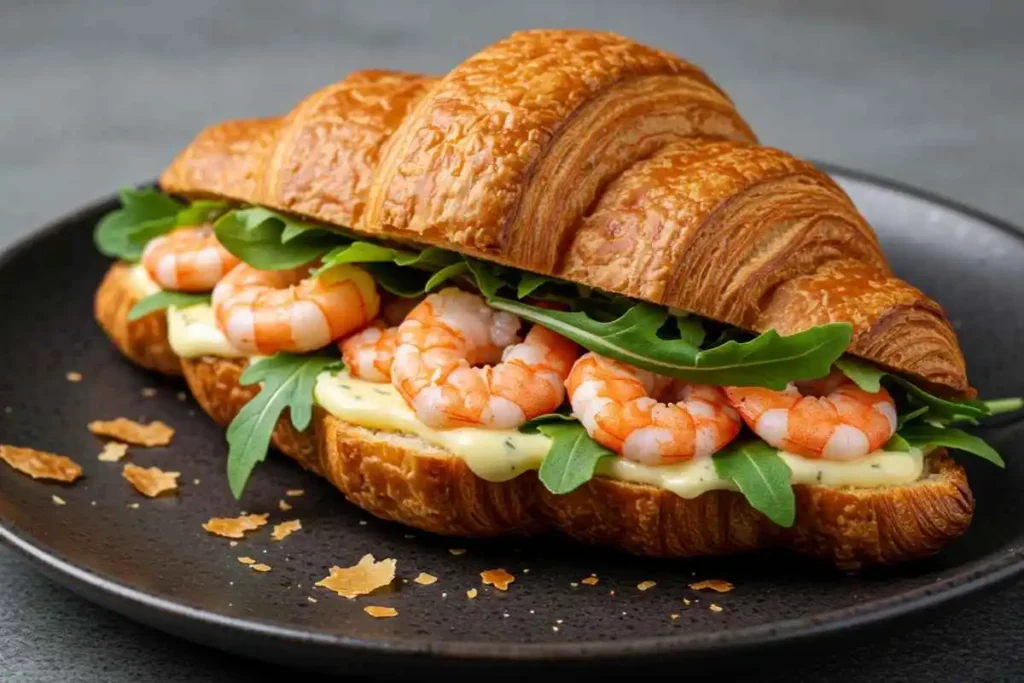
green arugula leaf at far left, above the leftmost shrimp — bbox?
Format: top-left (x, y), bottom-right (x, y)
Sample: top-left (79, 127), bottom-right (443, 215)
top-left (93, 187), bottom-right (182, 262)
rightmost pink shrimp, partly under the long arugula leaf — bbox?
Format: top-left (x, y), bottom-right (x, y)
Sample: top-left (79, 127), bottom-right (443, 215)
top-left (725, 371), bottom-right (896, 460)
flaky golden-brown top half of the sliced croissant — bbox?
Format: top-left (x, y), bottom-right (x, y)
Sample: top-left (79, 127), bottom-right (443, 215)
top-left (160, 30), bottom-right (974, 395)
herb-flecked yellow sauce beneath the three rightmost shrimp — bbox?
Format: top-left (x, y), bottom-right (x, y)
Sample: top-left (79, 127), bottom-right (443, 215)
top-left (314, 372), bottom-right (924, 498)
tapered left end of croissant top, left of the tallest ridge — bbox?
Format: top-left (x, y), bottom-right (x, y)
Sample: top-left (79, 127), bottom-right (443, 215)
top-left (160, 70), bottom-right (434, 227)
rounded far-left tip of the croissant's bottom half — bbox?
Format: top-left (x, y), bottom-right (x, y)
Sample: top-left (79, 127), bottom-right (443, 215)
top-left (93, 262), bottom-right (181, 376)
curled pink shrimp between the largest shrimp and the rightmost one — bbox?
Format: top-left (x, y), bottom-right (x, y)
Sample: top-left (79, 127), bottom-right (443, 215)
top-left (565, 353), bottom-right (741, 465)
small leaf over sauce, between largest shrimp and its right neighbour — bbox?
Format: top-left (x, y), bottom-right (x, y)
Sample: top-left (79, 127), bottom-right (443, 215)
top-left (532, 416), bottom-right (615, 495)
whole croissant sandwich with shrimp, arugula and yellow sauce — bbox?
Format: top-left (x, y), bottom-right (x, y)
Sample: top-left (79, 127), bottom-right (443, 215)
top-left (95, 30), bottom-right (1019, 569)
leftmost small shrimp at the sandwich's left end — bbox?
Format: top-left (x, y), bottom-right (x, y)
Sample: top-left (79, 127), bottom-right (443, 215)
top-left (142, 225), bottom-right (239, 292)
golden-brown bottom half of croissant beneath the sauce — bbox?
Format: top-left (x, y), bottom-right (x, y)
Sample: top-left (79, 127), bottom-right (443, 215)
top-left (97, 265), bottom-right (974, 569)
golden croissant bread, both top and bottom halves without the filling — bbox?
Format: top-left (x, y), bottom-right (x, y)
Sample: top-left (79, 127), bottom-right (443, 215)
top-left (95, 30), bottom-right (976, 568)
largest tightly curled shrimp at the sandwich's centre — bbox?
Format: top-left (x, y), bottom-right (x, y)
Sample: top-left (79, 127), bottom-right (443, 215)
top-left (391, 288), bottom-right (578, 429)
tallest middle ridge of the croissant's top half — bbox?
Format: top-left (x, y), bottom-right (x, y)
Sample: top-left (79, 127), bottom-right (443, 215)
top-left (367, 31), bottom-right (756, 273)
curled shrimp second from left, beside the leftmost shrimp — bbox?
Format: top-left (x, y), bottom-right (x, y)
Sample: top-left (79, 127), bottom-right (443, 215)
top-left (213, 263), bottom-right (380, 354)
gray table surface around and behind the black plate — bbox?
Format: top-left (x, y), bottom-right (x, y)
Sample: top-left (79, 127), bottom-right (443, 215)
top-left (0, 0), bottom-right (1024, 683)
